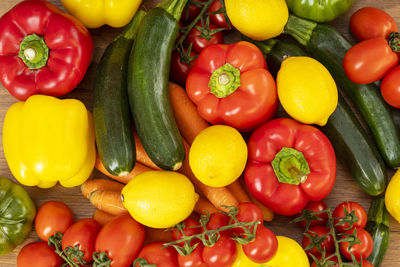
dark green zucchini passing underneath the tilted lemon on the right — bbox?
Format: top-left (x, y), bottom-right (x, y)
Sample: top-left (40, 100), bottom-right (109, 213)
top-left (254, 40), bottom-right (387, 196)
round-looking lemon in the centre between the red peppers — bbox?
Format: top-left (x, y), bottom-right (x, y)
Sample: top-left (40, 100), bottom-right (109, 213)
top-left (189, 125), bottom-right (247, 187)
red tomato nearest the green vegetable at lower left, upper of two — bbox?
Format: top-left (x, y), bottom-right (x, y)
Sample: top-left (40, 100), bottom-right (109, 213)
top-left (35, 201), bottom-right (74, 242)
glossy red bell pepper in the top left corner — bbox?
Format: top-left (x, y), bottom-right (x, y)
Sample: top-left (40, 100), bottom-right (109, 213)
top-left (0, 0), bottom-right (93, 101)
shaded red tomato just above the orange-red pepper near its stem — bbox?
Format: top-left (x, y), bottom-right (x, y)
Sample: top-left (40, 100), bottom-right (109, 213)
top-left (187, 22), bottom-right (224, 53)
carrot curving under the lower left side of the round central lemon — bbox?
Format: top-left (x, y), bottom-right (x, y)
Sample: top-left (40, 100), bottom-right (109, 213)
top-left (178, 140), bottom-right (239, 211)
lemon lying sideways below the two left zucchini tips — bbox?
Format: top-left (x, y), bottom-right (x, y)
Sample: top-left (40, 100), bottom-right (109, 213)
top-left (121, 171), bottom-right (199, 228)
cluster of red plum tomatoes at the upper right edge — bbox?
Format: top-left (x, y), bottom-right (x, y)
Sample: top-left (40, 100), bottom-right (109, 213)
top-left (343, 7), bottom-right (400, 108)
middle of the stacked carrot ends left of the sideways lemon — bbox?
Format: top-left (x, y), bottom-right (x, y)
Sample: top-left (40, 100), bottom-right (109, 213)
top-left (89, 190), bottom-right (127, 215)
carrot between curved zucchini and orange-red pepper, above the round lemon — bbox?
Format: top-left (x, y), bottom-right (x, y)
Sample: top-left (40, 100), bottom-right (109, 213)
top-left (169, 82), bottom-right (210, 144)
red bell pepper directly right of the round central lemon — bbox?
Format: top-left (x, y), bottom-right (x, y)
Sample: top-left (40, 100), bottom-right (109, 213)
top-left (244, 118), bottom-right (336, 215)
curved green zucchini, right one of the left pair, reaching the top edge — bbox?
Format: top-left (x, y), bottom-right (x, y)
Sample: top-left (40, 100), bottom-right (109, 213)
top-left (128, 0), bottom-right (187, 170)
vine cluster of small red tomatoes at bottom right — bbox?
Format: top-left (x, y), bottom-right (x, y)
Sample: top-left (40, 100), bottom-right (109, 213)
top-left (295, 201), bottom-right (373, 267)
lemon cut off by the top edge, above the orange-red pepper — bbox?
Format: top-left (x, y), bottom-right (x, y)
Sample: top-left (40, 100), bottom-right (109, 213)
top-left (225, 0), bottom-right (289, 40)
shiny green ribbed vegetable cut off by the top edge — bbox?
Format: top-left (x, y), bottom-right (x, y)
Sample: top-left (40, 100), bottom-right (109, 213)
top-left (286, 0), bottom-right (354, 22)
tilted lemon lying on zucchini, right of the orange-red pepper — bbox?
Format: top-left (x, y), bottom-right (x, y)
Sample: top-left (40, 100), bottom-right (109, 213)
top-left (277, 57), bottom-right (338, 126)
